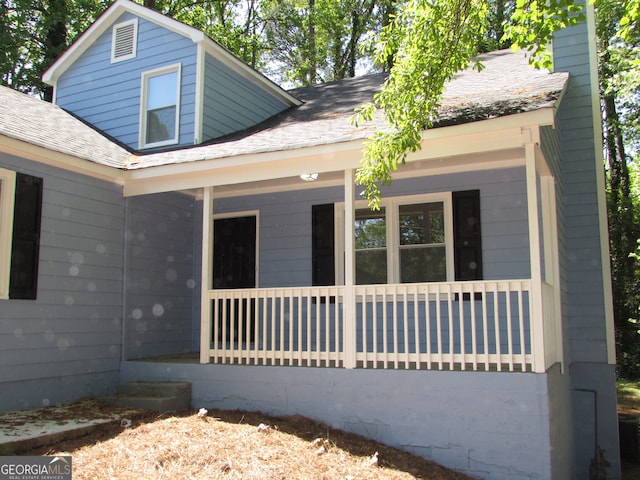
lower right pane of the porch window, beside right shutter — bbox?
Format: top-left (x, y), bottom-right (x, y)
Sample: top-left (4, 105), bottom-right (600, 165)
top-left (400, 247), bottom-right (447, 283)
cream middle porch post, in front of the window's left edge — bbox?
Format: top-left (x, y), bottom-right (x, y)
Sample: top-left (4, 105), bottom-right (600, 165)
top-left (343, 169), bottom-right (356, 368)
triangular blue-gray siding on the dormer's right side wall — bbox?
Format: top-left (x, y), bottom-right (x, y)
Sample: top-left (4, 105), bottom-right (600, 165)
top-left (202, 54), bottom-right (287, 141)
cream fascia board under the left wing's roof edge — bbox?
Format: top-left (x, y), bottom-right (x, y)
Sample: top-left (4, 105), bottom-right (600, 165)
top-left (0, 135), bottom-right (124, 185)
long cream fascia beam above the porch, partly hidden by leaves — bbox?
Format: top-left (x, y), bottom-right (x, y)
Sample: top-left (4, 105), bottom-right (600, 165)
top-left (124, 108), bottom-right (554, 196)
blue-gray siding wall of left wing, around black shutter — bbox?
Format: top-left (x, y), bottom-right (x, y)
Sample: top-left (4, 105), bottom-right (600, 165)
top-left (0, 154), bottom-right (124, 410)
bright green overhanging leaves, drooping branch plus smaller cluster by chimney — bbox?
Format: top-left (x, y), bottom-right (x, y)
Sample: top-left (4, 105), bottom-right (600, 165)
top-left (352, 0), bottom-right (581, 209)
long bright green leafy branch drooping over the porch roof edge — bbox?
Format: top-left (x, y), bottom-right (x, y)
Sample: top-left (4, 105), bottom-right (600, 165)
top-left (353, 0), bottom-right (487, 209)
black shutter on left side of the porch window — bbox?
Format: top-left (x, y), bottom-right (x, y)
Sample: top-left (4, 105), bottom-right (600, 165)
top-left (311, 203), bottom-right (336, 286)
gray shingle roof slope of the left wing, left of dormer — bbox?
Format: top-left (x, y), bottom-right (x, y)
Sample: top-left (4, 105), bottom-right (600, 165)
top-left (0, 86), bottom-right (131, 168)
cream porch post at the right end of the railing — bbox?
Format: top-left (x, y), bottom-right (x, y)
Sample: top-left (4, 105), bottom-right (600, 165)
top-left (523, 141), bottom-right (546, 373)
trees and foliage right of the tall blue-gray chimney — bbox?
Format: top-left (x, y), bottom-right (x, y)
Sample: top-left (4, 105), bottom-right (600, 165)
top-left (596, 0), bottom-right (640, 378)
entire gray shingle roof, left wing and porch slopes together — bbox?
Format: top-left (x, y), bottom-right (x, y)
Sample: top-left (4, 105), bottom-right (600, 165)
top-left (0, 50), bottom-right (568, 169)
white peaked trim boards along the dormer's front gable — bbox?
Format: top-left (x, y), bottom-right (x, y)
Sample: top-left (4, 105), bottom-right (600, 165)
top-left (42, 0), bottom-right (206, 86)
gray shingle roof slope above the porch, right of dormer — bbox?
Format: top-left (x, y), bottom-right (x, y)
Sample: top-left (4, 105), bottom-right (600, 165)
top-left (128, 50), bottom-right (569, 169)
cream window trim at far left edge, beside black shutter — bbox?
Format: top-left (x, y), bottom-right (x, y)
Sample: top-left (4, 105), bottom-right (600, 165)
top-left (0, 168), bottom-right (16, 299)
